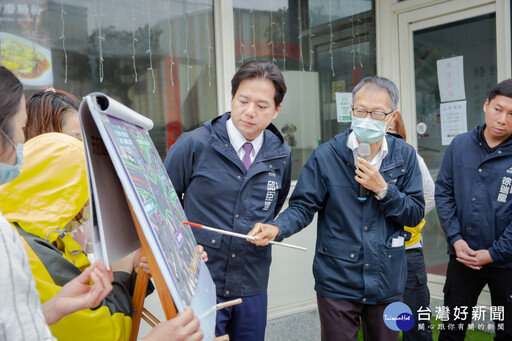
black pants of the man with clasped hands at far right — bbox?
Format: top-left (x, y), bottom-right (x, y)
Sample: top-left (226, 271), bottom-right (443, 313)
top-left (439, 255), bottom-right (512, 341)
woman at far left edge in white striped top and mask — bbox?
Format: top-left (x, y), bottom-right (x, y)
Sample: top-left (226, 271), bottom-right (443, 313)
top-left (0, 66), bottom-right (112, 340)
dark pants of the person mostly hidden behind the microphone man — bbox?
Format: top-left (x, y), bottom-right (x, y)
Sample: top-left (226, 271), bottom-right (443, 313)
top-left (403, 247), bottom-right (433, 341)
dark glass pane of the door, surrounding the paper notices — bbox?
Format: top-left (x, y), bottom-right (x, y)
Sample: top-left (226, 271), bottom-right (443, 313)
top-left (414, 14), bottom-right (497, 275)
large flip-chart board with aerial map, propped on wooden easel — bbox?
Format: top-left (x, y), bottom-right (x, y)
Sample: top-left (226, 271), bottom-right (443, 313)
top-left (80, 93), bottom-right (216, 340)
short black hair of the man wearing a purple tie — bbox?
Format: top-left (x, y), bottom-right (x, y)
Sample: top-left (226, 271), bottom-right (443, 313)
top-left (231, 60), bottom-right (286, 108)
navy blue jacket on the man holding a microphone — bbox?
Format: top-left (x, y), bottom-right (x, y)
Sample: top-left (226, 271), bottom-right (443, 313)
top-left (273, 129), bottom-right (425, 304)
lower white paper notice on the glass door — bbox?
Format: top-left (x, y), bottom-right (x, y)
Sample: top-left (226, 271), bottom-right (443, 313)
top-left (440, 101), bottom-right (468, 146)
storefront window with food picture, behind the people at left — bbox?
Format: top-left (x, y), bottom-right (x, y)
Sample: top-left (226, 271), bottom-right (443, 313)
top-left (0, 0), bottom-right (217, 157)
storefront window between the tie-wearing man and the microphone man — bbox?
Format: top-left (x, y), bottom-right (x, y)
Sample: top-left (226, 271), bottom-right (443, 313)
top-left (233, 0), bottom-right (376, 179)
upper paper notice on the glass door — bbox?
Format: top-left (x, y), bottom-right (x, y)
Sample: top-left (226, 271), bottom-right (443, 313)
top-left (437, 56), bottom-right (466, 102)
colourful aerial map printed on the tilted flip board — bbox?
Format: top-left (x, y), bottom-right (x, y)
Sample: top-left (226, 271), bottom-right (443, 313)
top-left (107, 115), bottom-right (200, 305)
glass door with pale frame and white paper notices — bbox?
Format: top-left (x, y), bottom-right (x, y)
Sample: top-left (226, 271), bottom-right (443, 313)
top-left (398, 0), bottom-right (504, 276)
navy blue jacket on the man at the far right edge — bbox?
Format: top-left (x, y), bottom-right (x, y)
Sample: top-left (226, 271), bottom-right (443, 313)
top-left (435, 126), bottom-right (512, 268)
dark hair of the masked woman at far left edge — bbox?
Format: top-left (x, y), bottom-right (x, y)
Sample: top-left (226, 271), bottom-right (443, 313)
top-left (0, 66), bottom-right (23, 150)
